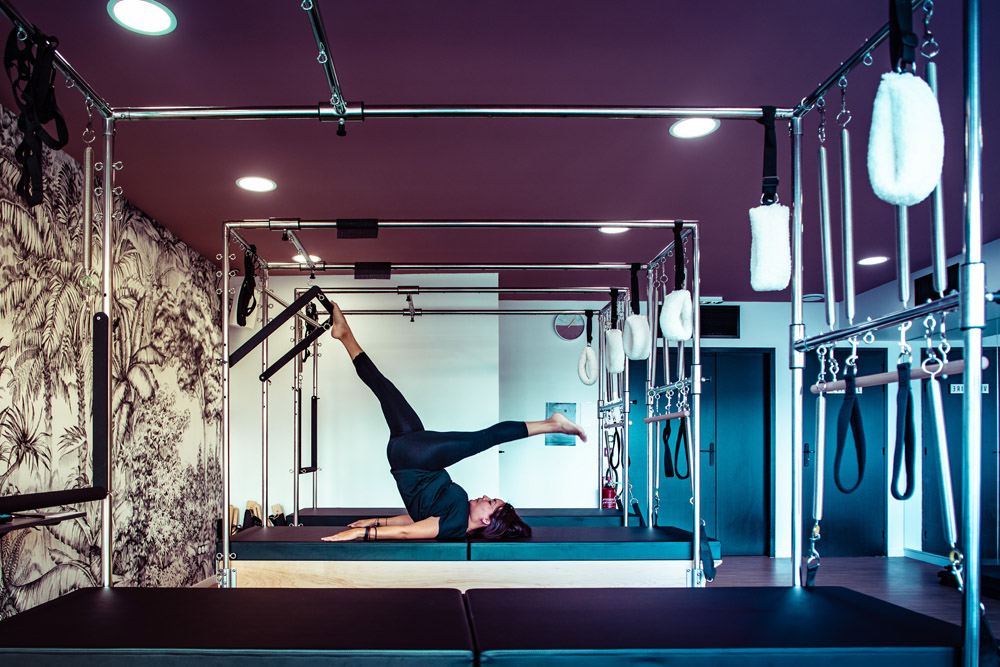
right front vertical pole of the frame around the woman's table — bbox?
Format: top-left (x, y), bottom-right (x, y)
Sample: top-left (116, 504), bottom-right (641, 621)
top-left (688, 227), bottom-right (705, 587)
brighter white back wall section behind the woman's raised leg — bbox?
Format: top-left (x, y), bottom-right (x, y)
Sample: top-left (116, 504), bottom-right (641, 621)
top-left (230, 274), bottom-right (499, 513)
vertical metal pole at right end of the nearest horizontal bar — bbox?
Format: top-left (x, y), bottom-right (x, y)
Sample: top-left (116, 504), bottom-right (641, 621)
top-left (788, 117), bottom-right (806, 586)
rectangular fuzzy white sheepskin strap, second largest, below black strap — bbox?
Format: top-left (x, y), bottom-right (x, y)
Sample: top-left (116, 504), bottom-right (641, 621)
top-left (750, 204), bottom-right (792, 292)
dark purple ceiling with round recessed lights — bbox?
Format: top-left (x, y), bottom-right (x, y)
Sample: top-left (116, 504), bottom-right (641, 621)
top-left (0, 0), bottom-right (1000, 300)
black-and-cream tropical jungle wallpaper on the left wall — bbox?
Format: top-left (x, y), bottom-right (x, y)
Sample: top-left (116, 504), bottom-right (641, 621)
top-left (0, 109), bottom-right (222, 618)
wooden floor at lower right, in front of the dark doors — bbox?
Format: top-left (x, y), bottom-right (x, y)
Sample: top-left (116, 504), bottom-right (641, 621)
top-left (709, 556), bottom-right (1000, 628)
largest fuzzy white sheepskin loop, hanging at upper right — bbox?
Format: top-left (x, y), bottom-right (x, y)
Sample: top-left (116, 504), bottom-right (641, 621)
top-left (868, 72), bottom-right (944, 206)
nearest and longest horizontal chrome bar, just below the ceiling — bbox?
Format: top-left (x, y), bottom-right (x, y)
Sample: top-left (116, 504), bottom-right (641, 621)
top-left (114, 102), bottom-right (795, 121)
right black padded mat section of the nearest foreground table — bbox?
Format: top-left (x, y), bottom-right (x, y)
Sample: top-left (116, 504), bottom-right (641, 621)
top-left (466, 587), bottom-right (961, 653)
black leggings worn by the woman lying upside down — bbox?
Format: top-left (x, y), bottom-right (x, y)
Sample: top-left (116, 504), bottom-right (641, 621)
top-left (354, 352), bottom-right (528, 470)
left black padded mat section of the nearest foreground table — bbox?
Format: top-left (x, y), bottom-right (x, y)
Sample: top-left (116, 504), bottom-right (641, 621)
top-left (0, 588), bottom-right (473, 652)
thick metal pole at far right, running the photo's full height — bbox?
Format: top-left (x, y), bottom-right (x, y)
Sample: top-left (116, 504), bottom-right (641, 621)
top-left (961, 0), bottom-right (986, 667)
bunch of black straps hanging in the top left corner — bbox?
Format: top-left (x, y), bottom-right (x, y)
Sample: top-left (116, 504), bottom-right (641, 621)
top-left (3, 27), bottom-right (69, 206)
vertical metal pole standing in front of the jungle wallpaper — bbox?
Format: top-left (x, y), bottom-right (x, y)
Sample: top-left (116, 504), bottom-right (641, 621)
top-left (94, 118), bottom-right (115, 588)
